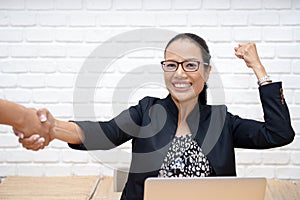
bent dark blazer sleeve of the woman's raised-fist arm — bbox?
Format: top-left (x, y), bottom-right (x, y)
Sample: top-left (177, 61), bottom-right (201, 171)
top-left (230, 82), bottom-right (295, 149)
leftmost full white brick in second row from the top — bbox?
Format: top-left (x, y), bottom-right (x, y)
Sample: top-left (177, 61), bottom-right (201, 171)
top-left (9, 12), bottom-right (36, 26)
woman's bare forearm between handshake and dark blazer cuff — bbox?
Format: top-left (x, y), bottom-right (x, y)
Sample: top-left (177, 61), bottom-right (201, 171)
top-left (53, 120), bottom-right (85, 144)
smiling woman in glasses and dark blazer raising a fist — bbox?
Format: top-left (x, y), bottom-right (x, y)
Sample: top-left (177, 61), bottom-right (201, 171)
top-left (20, 33), bottom-right (295, 200)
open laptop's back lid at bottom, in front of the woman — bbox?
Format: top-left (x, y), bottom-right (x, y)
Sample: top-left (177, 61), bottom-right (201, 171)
top-left (144, 177), bottom-right (267, 200)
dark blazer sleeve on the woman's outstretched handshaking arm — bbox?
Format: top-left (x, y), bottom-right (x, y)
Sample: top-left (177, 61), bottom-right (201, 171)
top-left (68, 98), bottom-right (147, 150)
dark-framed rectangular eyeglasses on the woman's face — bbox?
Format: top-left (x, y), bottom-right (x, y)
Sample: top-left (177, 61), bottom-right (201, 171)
top-left (160, 60), bottom-right (208, 72)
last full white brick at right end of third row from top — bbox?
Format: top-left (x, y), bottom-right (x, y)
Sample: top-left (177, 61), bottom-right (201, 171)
top-left (263, 27), bottom-right (293, 42)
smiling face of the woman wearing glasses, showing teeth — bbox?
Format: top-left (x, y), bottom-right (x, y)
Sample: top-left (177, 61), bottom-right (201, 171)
top-left (164, 39), bottom-right (210, 103)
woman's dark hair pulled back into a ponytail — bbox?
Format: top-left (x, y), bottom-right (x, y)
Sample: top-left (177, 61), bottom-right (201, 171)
top-left (164, 33), bottom-right (211, 105)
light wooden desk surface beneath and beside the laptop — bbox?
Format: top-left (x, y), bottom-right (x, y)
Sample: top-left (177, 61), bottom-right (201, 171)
top-left (0, 176), bottom-right (300, 200)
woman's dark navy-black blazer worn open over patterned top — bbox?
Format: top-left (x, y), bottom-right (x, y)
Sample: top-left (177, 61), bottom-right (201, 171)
top-left (69, 82), bottom-right (295, 200)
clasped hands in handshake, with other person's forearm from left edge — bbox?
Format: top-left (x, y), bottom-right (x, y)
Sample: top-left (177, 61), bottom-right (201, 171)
top-left (0, 99), bottom-right (56, 151)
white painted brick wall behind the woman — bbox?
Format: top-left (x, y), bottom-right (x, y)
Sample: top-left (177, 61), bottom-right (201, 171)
top-left (0, 0), bottom-right (300, 179)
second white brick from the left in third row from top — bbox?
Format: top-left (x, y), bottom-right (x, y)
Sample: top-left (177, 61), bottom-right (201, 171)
top-left (24, 28), bottom-right (54, 42)
